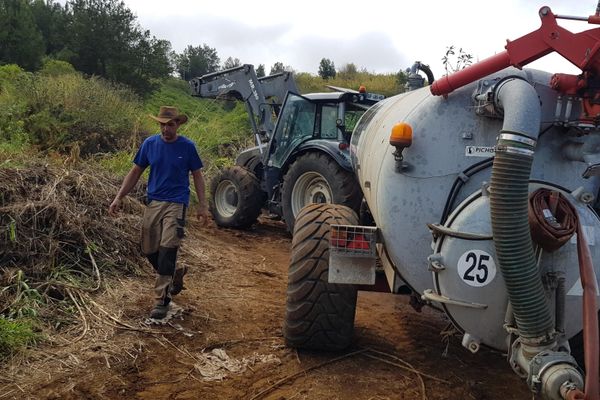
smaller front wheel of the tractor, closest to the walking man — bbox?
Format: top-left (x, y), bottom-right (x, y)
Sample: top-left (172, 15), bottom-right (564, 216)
top-left (210, 165), bottom-right (265, 229)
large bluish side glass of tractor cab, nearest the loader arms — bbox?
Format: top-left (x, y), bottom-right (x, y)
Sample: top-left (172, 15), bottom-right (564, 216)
top-left (269, 93), bottom-right (316, 168)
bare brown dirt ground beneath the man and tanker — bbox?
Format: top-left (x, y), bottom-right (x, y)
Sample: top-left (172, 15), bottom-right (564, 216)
top-left (0, 220), bottom-right (532, 400)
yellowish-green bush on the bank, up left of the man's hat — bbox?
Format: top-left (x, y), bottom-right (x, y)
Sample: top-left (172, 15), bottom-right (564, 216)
top-left (17, 74), bottom-right (141, 155)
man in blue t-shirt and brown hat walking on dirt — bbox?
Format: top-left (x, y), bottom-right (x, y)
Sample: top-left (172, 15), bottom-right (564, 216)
top-left (108, 106), bottom-right (208, 319)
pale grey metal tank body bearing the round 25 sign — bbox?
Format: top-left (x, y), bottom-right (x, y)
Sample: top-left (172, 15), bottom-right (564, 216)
top-left (351, 68), bottom-right (600, 350)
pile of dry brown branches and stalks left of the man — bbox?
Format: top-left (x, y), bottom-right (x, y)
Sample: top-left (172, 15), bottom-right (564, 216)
top-left (0, 165), bottom-right (143, 310)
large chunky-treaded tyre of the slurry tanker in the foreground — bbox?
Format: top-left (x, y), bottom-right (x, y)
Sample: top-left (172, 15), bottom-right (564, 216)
top-left (283, 204), bottom-right (358, 351)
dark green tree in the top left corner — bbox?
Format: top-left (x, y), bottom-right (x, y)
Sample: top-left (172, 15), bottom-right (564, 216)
top-left (0, 0), bottom-right (45, 70)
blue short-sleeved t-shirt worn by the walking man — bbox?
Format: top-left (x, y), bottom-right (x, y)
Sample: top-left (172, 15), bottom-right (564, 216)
top-left (133, 134), bottom-right (203, 206)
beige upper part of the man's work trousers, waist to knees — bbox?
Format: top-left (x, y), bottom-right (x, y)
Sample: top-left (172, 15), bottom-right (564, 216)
top-left (141, 200), bottom-right (186, 254)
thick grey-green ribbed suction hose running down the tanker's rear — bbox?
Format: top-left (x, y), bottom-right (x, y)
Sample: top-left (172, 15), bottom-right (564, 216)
top-left (490, 77), bottom-right (583, 400)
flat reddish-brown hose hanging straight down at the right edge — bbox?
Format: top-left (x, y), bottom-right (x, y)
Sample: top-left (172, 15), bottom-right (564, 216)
top-left (577, 221), bottom-right (600, 400)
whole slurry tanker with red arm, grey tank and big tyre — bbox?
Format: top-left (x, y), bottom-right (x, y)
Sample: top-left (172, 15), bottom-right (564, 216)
top-left (284, 4), bottom-right (600, 400)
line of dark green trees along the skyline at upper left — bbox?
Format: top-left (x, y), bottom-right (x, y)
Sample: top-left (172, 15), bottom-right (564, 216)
top-left (0, 0), bottom-right (296, 95)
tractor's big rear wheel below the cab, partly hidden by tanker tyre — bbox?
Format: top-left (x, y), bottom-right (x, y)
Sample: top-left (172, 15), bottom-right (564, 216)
top-left (281, 152), bottom-right (362, 232)
